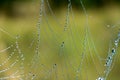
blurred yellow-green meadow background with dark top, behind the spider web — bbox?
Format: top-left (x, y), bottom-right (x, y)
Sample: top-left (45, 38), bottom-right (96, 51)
top-left (0, 0), bottom-right (120, 80)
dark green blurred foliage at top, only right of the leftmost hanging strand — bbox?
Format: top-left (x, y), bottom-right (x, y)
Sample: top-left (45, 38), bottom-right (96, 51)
top-left (51, 0), bottom-right (120, 9)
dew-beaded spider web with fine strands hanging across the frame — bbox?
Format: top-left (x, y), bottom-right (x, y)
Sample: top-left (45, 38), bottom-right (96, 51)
top-left (0, 0), bottom-right (120, 80)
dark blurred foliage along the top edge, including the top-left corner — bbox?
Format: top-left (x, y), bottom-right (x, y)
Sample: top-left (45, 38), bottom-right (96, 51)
top-left (0, 0), bottom-right (120, 17)
